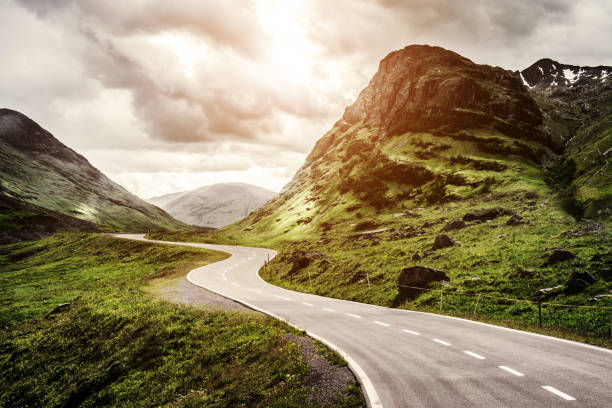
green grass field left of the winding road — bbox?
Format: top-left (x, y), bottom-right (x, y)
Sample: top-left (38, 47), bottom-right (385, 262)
top-left (0, 234), bottom-right (360, 407)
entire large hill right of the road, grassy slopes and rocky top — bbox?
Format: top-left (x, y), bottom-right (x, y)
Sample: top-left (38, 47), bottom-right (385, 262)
top-left (148, 46), bottom-right (612, 343)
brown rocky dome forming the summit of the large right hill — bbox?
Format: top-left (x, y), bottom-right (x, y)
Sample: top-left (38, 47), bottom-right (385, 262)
top-left (343, 45), bottom-right (542, 138)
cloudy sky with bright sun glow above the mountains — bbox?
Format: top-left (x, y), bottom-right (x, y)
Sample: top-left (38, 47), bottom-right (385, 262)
top-left (0, 0), bottom-right (612, 198)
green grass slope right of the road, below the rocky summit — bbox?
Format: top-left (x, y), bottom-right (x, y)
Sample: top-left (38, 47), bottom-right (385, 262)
top-left (147, 123), bottom-right (612, 347)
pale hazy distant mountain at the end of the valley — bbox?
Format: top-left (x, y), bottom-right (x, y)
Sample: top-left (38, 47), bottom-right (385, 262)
top-left (147, 183), bottom-right (276, 228)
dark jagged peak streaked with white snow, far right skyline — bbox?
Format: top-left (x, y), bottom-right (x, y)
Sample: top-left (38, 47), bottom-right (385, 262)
top-left (520, 58), bottom-right (612, 89)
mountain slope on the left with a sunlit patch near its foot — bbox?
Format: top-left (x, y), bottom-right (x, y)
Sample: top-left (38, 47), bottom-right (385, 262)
top-left (0, 109), bottom-right (184, 231)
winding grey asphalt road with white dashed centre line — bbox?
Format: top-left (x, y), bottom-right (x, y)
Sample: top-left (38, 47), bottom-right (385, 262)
top-left (118, 234), bottom-right (612, 408)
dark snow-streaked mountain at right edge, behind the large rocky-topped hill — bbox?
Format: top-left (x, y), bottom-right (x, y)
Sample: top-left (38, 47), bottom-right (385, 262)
top-left (520, 58), bottom-right (612, 217)
